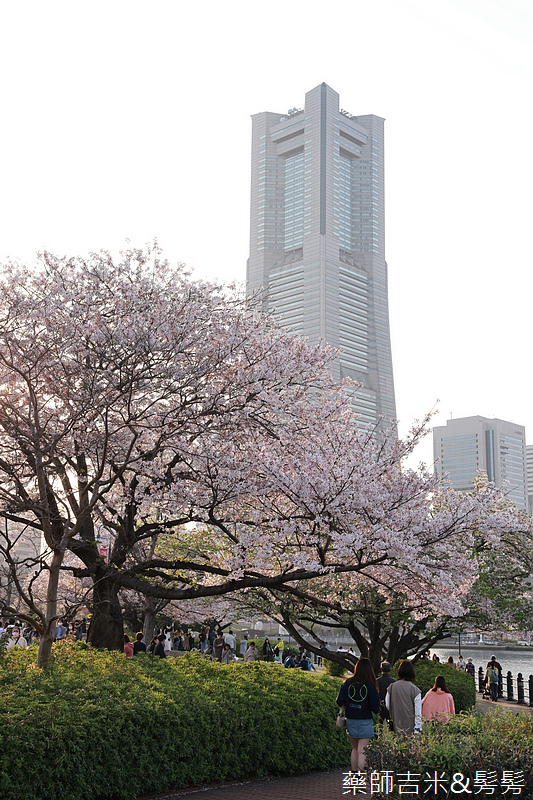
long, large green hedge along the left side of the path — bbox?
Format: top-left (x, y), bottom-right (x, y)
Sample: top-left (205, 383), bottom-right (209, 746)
top-left (0, 642), bottom-right (349, 800)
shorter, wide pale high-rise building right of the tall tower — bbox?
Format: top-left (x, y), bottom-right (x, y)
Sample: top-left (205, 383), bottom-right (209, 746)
top-left (433, 417), bottom-right (528, 511)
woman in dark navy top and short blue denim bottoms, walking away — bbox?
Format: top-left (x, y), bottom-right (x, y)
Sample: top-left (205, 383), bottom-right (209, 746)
top-left (337, 658), bottom-right (379, 772)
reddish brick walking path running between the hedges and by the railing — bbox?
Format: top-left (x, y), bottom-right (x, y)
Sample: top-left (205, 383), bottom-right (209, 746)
top-left (138, 695), bottom-right (533, 800)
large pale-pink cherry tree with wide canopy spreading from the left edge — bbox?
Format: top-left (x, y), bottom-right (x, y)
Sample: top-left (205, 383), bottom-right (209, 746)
top-left (0, 241), bottom-right (520, 663)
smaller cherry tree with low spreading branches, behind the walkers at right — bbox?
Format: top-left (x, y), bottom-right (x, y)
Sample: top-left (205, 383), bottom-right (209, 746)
top-left (233, 480), bottom-right (533, 670)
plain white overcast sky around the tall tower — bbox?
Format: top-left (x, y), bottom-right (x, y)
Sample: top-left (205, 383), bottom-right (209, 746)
top-left (0, 0), bottom-right (533, 463)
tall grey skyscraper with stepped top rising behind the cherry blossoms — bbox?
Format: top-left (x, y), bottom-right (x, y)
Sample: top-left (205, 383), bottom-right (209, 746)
top-left (248, 83), bottom-right (396, 426)
